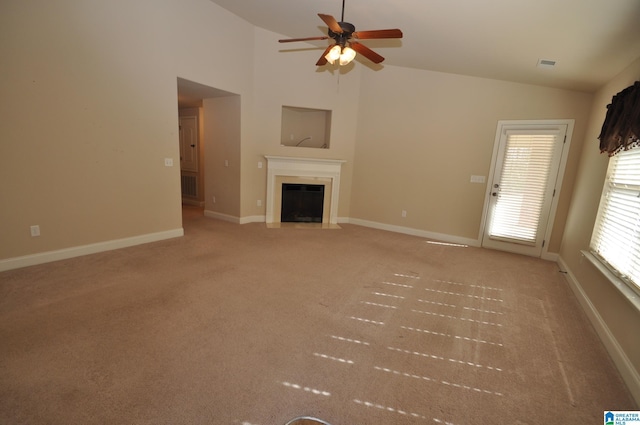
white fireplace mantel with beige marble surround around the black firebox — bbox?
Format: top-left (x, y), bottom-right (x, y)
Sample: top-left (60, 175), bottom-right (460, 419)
top-left (265, 155), bottom-right (346, 226)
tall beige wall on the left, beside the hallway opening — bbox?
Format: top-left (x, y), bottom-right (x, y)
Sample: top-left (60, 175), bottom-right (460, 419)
top-left (0, 0), bottom-right (253, 260)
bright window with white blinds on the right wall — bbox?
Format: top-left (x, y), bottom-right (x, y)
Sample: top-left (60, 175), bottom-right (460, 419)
top-left (591, 149), bottom-right (640, 293)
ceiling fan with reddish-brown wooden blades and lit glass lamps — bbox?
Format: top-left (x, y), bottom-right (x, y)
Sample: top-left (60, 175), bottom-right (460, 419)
top-left (278, 0), bottom-right (402, 66)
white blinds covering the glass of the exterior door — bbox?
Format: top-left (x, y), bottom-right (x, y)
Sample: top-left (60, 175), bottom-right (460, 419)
top-left (489, 131), bottom-right (558, 245)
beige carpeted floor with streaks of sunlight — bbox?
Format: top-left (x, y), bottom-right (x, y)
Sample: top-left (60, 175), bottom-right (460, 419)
top-left (0, 207), bottom-right (638, 425)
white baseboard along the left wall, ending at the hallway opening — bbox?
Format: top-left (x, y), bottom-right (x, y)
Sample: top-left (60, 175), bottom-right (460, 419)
top-left (0, 228), bottom-right (184, 271)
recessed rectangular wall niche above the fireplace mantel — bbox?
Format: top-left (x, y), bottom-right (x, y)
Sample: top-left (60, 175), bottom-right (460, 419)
top-left (280, 106), bottom-right (331, 149)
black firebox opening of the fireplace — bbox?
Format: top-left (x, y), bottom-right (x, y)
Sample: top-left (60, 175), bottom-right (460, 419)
top-left (280, 183), bottom-right (324, 223)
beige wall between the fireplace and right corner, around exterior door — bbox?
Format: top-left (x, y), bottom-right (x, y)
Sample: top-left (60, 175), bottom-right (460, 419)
top-left (350, 66), bottom-right (592, 247)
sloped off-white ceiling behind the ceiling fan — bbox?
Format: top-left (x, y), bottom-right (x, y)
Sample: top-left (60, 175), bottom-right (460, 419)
top-left (211, 0), bottom-right (640, 92)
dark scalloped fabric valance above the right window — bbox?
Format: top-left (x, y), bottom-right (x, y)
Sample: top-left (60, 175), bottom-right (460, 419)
top-left (598, 81), bottom-right (640, 156)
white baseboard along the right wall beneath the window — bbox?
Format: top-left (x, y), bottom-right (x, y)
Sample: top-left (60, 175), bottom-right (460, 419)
top-left (558, 257), bottom-right (640, 404)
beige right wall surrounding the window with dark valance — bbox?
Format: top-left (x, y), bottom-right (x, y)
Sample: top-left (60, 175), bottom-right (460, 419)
top-left (560, 59), bottom-right (640, 400)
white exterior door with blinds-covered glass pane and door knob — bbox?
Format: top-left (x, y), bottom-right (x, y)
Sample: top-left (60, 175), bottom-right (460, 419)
top-left (482, 121), bottom-right (568, 257)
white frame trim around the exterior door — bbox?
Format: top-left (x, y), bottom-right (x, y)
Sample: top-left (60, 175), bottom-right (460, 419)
top-left (478, 119), bottom-right (575, 261)
